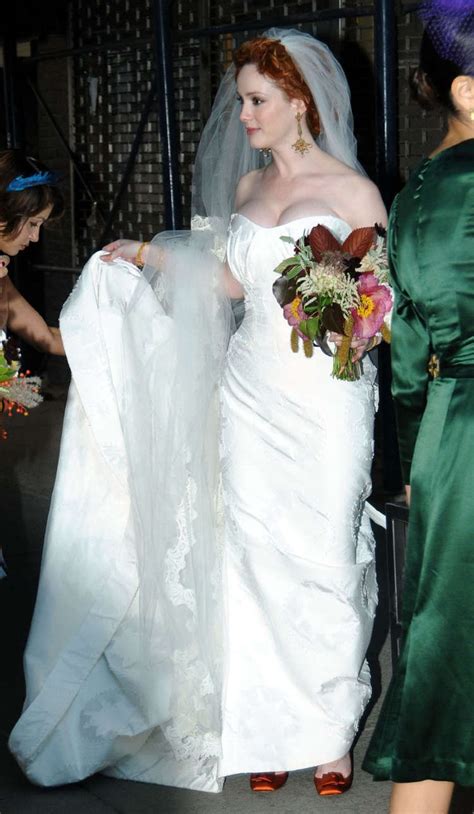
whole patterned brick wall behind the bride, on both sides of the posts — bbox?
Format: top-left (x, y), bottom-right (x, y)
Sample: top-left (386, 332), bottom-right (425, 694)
top-left (19, 0), bottom-right (442, 298)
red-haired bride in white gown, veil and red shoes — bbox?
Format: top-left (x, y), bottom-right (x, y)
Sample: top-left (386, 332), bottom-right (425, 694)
top-left (10, 30), bottom-right (386, 795)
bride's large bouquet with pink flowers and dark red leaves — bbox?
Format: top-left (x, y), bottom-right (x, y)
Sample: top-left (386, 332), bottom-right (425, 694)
top-left (273, 224), bottom-right (393, 381)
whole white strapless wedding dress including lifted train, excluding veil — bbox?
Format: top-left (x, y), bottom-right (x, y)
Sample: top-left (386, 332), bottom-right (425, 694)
top-left (10, 214), bottom-right (376, 791)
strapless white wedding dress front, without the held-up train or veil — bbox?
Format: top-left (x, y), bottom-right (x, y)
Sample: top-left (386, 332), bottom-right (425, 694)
top-left (219, 214), bottom-right (376, 775)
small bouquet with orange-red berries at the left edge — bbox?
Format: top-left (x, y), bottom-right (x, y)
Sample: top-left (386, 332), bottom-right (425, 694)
top-left (0, 342), bottom-right (43, 438)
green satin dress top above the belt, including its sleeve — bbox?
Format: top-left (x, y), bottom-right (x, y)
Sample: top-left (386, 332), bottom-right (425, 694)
top-left (388, 139), bottom-right (474, 483)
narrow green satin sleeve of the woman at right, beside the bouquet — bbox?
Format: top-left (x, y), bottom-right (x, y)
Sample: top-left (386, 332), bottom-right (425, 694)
top-left (388, 200), bottom-right (430, 484)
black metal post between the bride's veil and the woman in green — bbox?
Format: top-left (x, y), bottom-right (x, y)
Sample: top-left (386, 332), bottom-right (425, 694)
top-left (374, 0), bottom-right (398, 207)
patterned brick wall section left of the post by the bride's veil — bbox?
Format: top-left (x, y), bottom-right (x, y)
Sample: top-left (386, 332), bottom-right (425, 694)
top-left (72, 0), bottom-right (163, 262)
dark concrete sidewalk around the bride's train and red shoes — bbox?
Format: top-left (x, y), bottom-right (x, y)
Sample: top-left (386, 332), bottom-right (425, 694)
top-left (0, 385), bottom-right (474, 814)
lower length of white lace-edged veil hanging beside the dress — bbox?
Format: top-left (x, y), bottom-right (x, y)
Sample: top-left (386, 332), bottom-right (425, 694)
top-left (116, 232), bottom-right (232, 791)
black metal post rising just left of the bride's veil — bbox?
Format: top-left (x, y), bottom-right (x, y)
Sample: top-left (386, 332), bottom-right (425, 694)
top-left (153, 0), bottom-right (182, 229)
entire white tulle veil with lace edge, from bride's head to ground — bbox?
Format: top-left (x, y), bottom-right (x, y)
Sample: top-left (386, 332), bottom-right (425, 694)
top-left (118, 29), bottom-right (362, 791)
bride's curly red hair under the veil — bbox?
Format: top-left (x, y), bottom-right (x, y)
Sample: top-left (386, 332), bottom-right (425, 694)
top-left (233, 37), bottom-right (321, 136)
